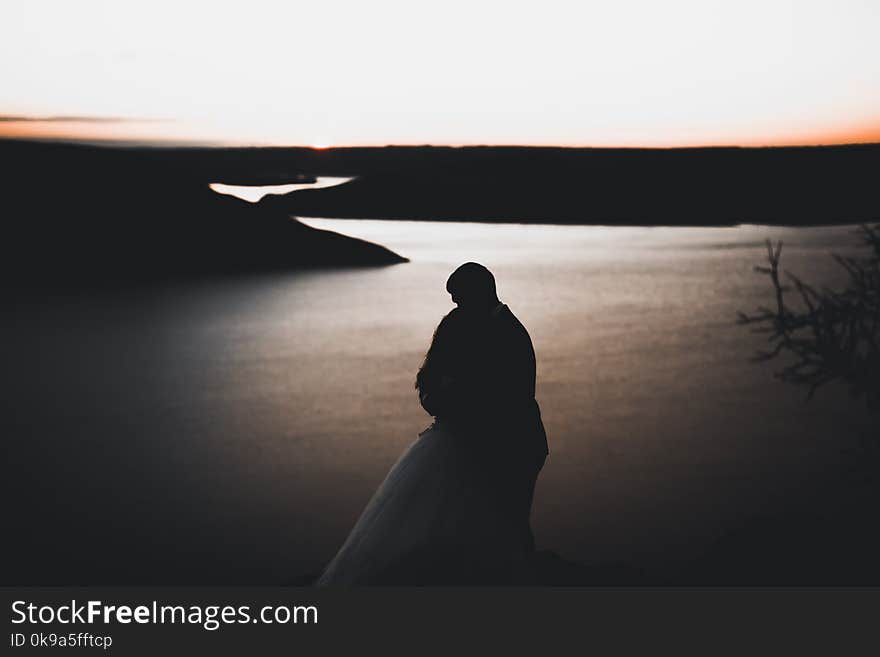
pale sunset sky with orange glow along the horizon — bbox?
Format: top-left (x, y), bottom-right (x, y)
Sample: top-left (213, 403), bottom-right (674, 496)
top-left (0, 0), bottom-right (880, 146)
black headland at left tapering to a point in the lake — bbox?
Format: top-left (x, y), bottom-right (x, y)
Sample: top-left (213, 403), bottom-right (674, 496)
top-left (0, 142), bottom-right (406, 288)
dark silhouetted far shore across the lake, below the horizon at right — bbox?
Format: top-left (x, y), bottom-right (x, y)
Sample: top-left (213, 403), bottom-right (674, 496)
top-left (263, 145), bottom-right (880, 226)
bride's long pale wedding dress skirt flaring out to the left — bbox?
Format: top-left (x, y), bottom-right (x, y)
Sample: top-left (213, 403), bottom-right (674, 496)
top-left (316, 424), bottom-right (526, 586)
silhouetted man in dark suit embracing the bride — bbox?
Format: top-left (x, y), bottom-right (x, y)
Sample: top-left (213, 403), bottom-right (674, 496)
top-left (416, 262), bottom-right (548, 551)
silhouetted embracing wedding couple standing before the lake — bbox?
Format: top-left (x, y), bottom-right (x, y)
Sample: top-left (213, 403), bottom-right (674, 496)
top-left (318, 262), bottom-right (547, 586)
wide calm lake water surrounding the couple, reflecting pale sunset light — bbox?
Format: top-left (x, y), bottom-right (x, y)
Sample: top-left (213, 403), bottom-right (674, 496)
top-left (7, 214), bottom-right (867, 583)
